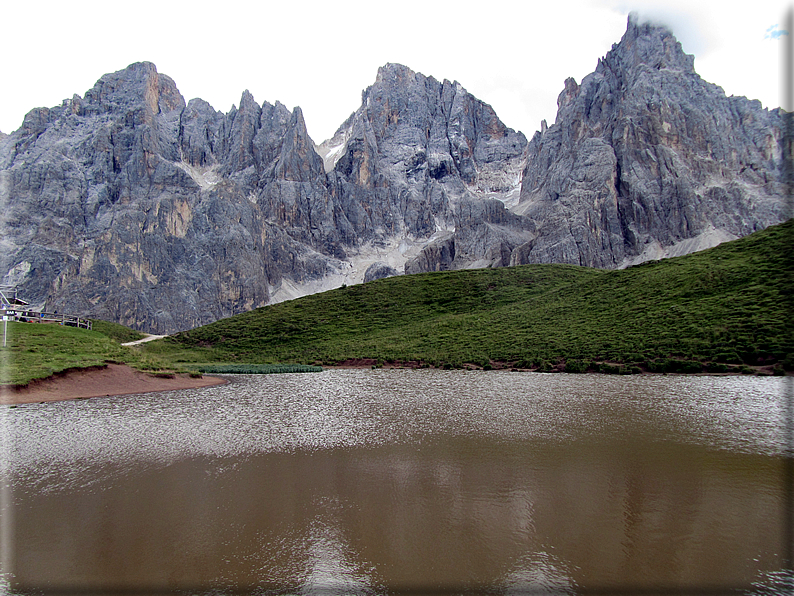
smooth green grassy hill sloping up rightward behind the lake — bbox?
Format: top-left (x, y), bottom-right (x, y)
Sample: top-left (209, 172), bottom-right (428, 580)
top-left (142, 220), bottom-right (794, 372)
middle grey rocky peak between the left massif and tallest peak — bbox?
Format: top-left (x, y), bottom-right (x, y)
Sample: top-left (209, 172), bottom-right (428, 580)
top-left (318, 64), bottom-right (527, 241)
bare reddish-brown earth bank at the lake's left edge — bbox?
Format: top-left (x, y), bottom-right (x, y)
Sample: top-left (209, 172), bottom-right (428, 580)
top-left (0, 364), bottom-right (228, 405)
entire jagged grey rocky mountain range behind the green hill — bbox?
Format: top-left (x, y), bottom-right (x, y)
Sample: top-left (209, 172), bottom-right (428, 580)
top-left (0, 16), bottom-right (786, 333)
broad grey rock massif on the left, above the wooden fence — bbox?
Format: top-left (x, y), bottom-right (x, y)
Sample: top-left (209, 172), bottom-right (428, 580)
top-left (0, 63), bottom-right (340, 333)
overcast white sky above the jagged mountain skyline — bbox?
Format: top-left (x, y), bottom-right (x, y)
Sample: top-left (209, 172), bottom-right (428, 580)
top-left (0, 0), bottom-right (790, 143)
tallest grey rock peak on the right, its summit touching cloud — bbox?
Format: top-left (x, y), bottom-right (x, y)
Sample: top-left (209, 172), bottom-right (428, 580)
top-left (511, 18), bottom-right (783, 268)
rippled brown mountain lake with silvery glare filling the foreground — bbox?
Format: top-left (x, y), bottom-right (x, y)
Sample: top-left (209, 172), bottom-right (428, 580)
top-left (0, 370), bottom-right (787, 594)
